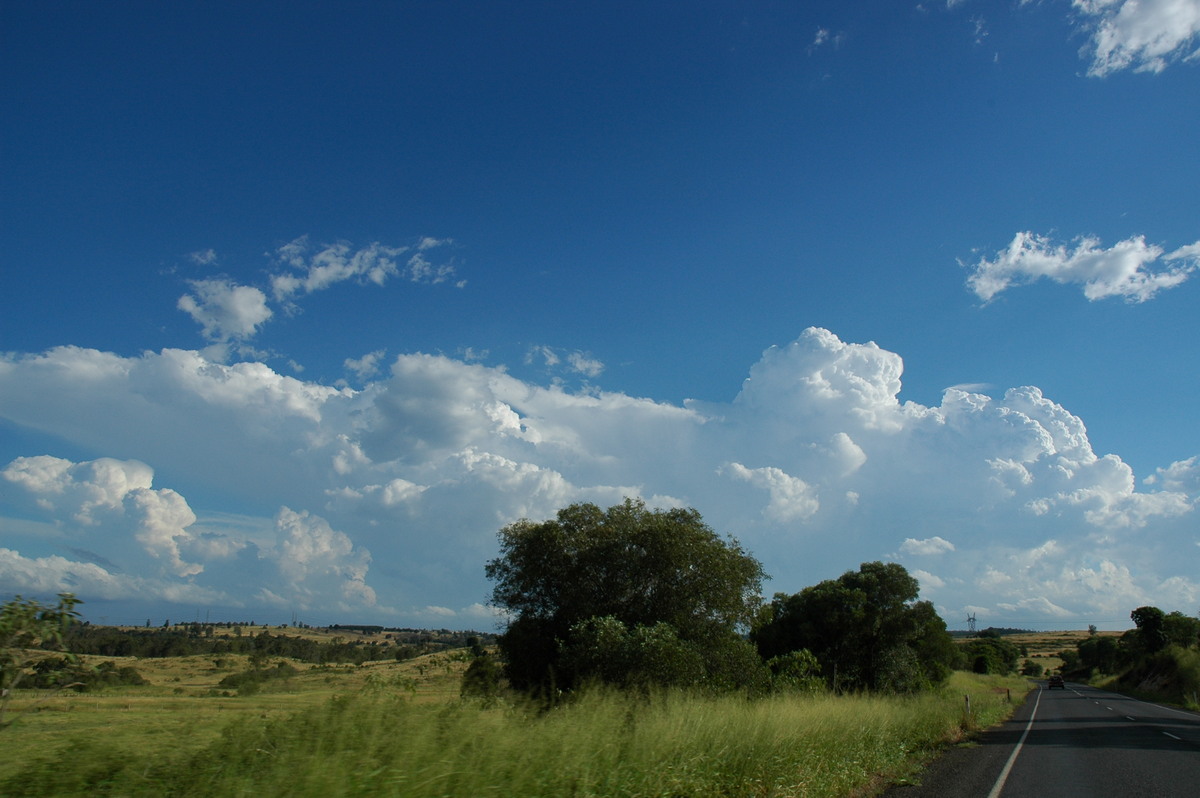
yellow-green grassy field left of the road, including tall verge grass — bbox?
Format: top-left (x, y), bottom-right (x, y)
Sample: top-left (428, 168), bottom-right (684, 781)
top-left (0, 653), bottom-right (1026, 797)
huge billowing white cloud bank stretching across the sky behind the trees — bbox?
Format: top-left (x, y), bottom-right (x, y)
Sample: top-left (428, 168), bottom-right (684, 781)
top-left (0, 328), bottom-right (1200, 623)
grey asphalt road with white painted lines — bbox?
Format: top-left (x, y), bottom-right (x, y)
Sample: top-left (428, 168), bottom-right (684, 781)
top-left (884, 682), bottom-right (1200, 798)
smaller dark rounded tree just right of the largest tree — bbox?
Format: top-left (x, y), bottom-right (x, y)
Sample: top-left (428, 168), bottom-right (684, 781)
top-left (751, 563), bottom-right (955, 691)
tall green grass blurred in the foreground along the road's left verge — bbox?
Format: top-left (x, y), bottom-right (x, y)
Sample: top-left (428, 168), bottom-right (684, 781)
top-left (0, 680), bottom-right (1024, 798)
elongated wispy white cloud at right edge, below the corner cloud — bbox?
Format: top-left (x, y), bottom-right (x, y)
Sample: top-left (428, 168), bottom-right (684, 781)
top-left (967, 232), bottom-right (1200, 302)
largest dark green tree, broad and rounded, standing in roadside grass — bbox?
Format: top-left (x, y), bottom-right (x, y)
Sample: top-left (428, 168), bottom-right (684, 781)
top-left (486, 499), bottom-right (764, 689)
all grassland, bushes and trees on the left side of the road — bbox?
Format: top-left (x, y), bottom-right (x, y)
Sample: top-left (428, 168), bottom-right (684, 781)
top-left (0, 500), bottom-right (1051, 797)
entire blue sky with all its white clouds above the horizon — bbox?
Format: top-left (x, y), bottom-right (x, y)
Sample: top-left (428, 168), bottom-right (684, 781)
top-left (0, 0), bottom-right (1200, 628)
